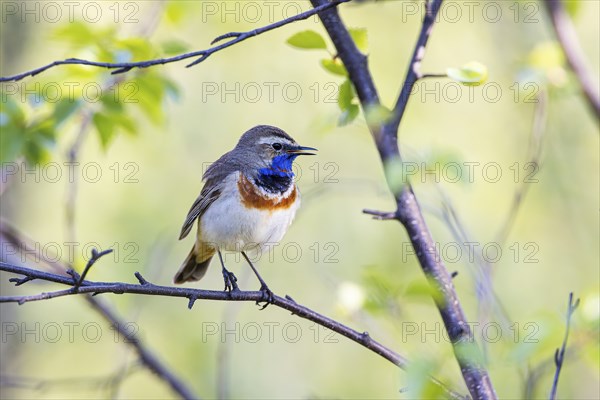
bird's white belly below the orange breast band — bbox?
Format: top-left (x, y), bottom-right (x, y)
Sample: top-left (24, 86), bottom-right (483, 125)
top-left (198, 173), bottom-right (300, 251)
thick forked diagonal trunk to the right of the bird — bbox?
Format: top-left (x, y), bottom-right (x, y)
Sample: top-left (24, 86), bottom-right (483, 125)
top-left (311, 0), bottom-right (496, 399)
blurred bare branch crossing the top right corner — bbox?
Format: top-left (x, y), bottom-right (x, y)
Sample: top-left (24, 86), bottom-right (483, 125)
top-left (542, 0), bottom-right (600, 119)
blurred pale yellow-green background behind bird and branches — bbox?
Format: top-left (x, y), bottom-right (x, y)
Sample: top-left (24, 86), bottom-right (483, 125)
top-left (0, 1), bottom-right (600, 399)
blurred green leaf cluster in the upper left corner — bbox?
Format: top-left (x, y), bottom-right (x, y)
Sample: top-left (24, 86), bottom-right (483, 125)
top-left (0, 21), bottom-right (185, 164)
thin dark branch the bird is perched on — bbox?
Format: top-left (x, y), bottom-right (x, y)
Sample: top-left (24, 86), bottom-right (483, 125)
top-left (0, 261), bottom-right (465, 399)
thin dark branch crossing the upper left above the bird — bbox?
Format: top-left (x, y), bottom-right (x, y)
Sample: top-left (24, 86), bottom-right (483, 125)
top-left (0, 0), bottom-right (351, 82)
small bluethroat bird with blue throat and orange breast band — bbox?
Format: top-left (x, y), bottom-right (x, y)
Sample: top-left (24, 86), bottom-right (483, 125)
top-left (174, 125), bottom-right (316, 308)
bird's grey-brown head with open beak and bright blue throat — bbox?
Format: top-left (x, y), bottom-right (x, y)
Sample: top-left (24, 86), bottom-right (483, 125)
top-left (234, 125), bottom-right (317, 178)
